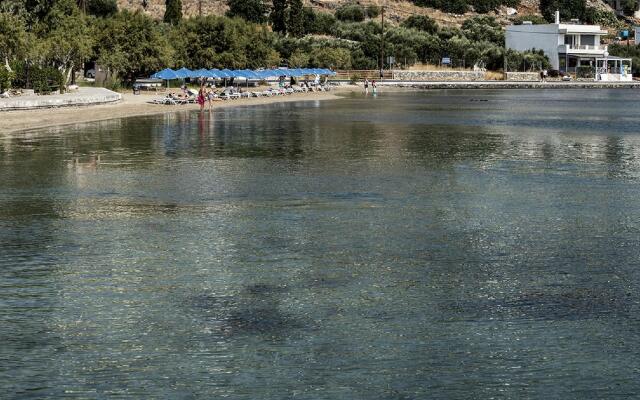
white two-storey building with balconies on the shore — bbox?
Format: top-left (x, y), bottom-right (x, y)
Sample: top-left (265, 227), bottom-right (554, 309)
top-left (506, 12), bottom-right (632, 81)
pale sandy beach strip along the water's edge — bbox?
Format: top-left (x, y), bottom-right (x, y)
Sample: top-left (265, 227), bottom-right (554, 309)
top-left (0, 86), bottom-right (354, 134)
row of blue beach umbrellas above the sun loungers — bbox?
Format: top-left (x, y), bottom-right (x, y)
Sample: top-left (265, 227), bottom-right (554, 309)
top-left (151, 68), bottom-right (336, 80)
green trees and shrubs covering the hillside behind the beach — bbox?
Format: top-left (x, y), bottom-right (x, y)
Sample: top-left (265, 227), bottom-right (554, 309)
top-left (0, 0), bottom-right (640, 92)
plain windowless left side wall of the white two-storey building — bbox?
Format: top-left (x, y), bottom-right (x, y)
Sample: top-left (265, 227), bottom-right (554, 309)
top-left (505, 24), bottom-right (564, 69)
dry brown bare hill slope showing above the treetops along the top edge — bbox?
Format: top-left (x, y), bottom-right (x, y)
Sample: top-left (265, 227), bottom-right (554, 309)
top-left (118, 0), bottom-right (612, 25)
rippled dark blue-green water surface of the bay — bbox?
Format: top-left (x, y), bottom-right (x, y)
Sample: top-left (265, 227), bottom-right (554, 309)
top-left (0, 90), bottom-right (640, 400)
